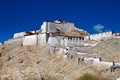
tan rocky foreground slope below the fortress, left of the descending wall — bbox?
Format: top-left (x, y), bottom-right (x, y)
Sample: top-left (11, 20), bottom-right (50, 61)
top-left (0, 44), bottom-right (99, 80)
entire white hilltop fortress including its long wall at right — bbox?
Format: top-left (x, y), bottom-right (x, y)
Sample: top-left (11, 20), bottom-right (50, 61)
top-left (4, 20), bottom-right (115, 47)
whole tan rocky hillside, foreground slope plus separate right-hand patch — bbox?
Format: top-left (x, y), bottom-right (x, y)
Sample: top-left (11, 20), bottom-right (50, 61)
top-left (0, 39), bottom-right (120, 80)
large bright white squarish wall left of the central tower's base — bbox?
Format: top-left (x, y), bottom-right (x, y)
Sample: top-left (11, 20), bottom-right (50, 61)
top-left (23, 35), bottom-right (37, 45)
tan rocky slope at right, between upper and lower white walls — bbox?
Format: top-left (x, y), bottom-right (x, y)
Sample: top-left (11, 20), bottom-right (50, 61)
top-left (90, 38), bottom-right (120, 62)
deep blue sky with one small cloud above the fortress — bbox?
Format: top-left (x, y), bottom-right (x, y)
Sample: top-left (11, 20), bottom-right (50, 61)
top-left (0, 0), bottom-right (120, 42)
